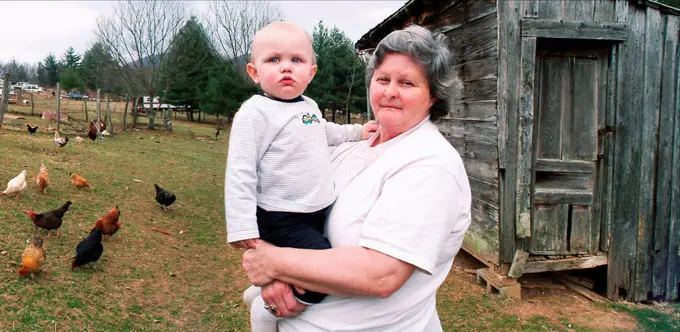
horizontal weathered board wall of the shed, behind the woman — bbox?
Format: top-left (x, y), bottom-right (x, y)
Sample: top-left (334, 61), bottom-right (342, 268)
top-left (428, 0), bottom-right (500, 264)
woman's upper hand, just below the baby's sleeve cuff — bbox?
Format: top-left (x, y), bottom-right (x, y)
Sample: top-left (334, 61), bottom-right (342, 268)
top-left (241, 240), bottom-right (276, 286)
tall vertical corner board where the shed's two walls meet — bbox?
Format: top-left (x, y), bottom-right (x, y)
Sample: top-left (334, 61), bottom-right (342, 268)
top-left (497, 1), bottom-right (522, 263)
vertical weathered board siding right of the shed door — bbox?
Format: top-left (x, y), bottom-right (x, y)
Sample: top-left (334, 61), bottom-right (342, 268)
top-left (608, 3), bottom-right (680, 301)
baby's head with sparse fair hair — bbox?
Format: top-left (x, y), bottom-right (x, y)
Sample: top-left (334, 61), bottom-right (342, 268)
top-left (246, 22), bottom-right (316, 99)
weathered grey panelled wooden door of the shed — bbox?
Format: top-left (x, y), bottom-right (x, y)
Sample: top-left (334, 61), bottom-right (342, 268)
top-left (530, 43), bottom-right (609, 255)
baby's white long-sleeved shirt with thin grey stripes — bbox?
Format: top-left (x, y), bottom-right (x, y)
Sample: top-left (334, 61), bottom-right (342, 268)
top-left (224, 95), bottom-right (361, 243)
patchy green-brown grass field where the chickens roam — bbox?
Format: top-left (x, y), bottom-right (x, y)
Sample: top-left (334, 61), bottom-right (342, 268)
top-left (0, 111), bottom-right (677, 331)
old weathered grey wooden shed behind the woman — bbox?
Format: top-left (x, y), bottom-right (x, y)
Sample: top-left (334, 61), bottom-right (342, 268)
top-left (356, 0), bottom-right (680, 301)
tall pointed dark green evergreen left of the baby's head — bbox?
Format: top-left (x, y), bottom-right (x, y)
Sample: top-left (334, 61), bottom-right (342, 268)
top-left (163, 16), bottom-right (221, 114)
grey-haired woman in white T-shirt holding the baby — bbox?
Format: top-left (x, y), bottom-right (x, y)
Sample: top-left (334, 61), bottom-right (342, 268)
top-left (243, 26), bottom-right (471, 332)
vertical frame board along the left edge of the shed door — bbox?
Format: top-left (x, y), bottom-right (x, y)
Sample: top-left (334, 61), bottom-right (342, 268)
top-left (515, 37), bottom-right (536, 238)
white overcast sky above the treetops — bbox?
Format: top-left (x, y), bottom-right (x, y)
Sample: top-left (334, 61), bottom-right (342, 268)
top-left (0, 0), bottom-right (406, 64)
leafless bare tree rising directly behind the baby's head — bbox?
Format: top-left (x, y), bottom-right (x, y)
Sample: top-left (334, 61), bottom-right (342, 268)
top-left (205, 0), bottom-right (284, 67)
